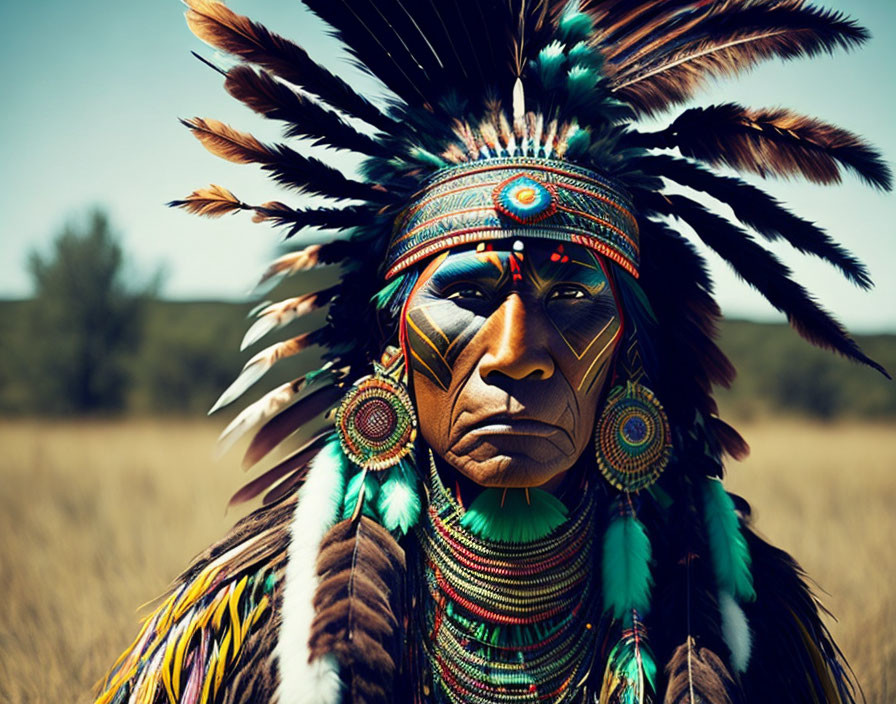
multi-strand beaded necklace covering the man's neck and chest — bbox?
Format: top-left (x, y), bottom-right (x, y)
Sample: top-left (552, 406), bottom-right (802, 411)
top-left (415, 459), bottom-right (600, 704)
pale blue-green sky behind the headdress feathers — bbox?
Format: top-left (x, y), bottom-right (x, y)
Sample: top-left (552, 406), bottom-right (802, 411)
top-left (0, 0), bottom-right (896, 332)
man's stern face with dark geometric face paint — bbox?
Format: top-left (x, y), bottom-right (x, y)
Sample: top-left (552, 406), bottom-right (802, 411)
top-left (404, 240), bottom-right (621, 487)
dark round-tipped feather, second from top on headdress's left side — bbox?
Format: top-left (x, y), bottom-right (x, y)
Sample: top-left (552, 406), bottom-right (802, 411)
top-left (224, 66), bottom-right (392, 158)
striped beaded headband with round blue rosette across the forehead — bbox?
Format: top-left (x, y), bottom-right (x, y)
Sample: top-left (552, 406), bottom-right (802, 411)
top-left (386, 157), bottom-right (638, 280)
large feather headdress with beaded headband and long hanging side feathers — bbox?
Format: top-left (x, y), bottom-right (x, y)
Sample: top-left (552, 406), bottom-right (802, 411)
top-left (96, 0), bottom-right (880, 704)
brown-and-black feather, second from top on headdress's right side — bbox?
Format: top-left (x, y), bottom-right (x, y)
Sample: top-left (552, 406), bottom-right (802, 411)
top-left (631, 103), bottom-right (893, 191)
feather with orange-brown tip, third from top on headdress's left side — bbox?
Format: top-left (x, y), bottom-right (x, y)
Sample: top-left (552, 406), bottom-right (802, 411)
top-left (181, 117), bottom-right (385, 202)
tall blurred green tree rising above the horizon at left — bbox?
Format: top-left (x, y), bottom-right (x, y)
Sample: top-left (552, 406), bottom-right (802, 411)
top-left (28, 209), bottom-right (157, 413)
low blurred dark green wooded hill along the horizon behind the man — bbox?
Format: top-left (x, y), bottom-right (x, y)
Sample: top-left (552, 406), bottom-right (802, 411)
top-left (0, 301), bottom-right (896, 419)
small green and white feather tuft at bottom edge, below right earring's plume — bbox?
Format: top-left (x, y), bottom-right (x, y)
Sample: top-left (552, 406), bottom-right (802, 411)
top-left (600, 616), bottom-right (656, 704)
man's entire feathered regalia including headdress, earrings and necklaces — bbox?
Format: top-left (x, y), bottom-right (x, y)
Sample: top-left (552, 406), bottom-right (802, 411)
top-left (99, 0), bottom-right (891, 704)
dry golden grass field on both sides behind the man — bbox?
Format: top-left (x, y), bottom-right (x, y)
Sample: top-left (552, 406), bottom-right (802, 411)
top-left (0, 420), bottom-right (896, 704)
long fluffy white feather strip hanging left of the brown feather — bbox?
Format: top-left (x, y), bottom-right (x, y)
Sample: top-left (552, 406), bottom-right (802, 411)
top-left (275, 448), bottom-right (345, 704)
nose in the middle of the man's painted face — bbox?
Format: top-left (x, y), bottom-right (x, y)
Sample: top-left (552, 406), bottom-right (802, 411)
top-left (479, 293), bottom-right (554, 383)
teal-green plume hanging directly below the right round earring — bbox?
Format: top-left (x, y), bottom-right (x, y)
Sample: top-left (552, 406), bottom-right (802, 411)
top-left (602, 509), bottom-right (652, 618)
